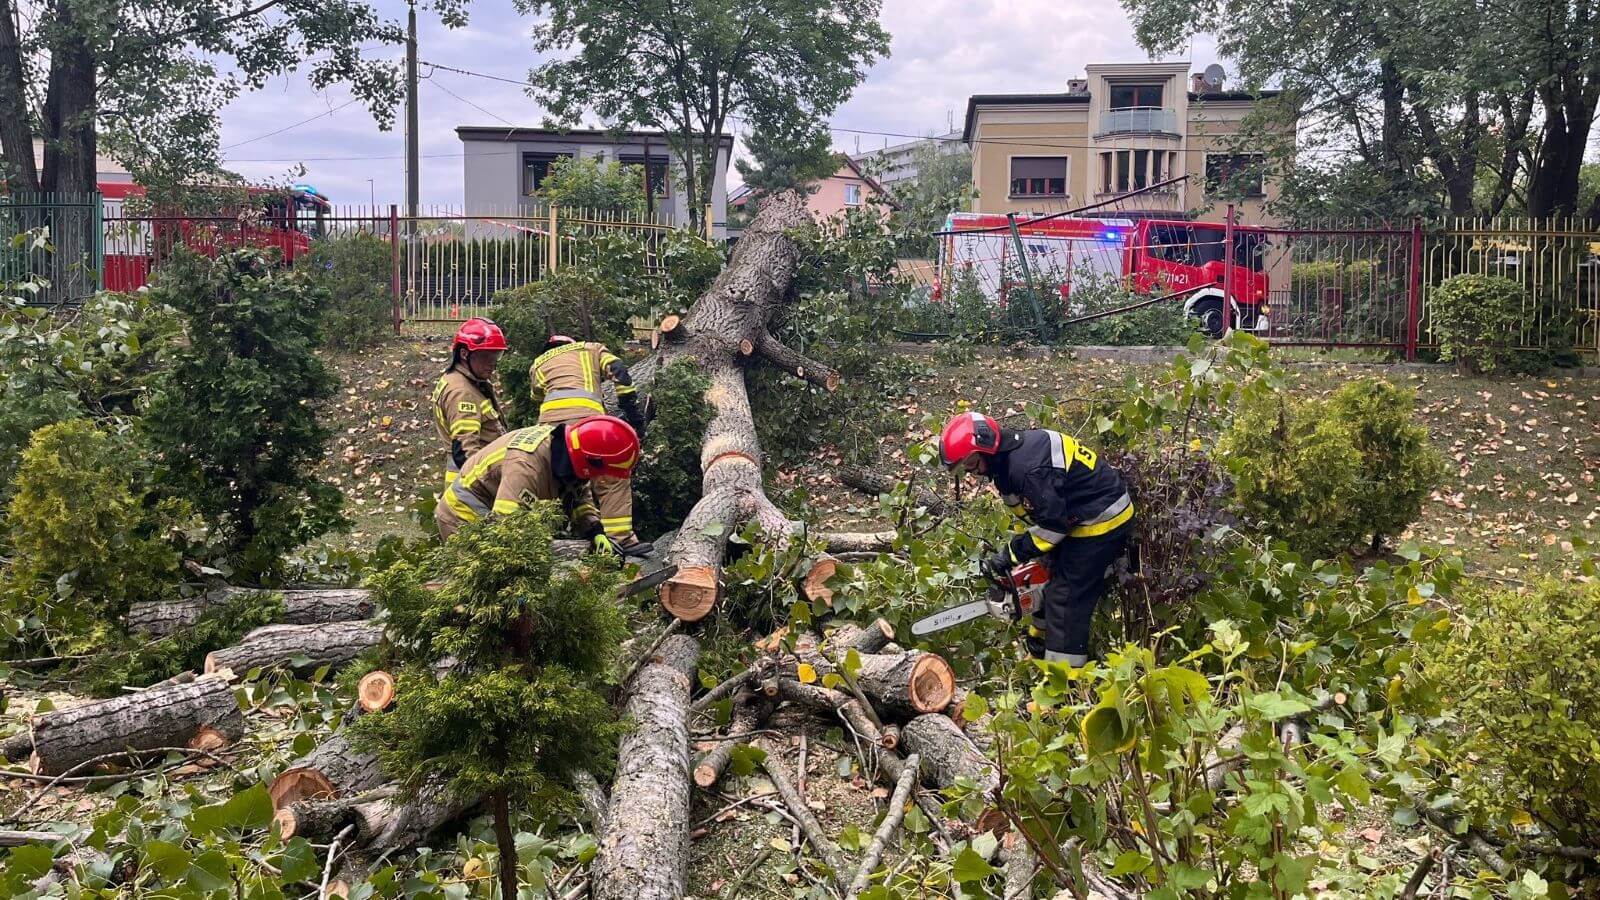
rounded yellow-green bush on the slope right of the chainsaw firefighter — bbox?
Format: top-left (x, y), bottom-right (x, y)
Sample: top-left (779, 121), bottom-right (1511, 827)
top-left (1218, 371), bottom-right (1443, 556)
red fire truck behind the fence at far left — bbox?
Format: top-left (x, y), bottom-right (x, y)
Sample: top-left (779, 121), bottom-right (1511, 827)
top-left (99, 181), bottom-right (330, 290)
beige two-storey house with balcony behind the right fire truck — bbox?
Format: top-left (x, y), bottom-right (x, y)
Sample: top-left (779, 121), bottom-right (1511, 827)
top-left (962, 62), bottom-right (1277, 224)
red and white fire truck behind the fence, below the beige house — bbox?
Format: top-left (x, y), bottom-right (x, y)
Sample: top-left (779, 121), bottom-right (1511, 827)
top-left (934, 213), bottom-right (1269, 336)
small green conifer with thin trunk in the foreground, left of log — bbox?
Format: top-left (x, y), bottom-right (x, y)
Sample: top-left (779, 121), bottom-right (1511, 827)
top-left (354, 503), bottom-right (629, 897)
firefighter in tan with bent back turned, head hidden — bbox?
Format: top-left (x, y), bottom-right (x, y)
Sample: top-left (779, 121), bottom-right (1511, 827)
top-left (528, 335), bottom-right (645, 546)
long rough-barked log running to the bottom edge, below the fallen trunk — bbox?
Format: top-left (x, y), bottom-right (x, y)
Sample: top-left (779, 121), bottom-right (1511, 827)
top-left (590, 634), bottom-right (699, 900)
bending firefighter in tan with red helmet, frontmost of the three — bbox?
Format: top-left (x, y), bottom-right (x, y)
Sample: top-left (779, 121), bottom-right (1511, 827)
top-left (434, 416), bottom-right (654, 556)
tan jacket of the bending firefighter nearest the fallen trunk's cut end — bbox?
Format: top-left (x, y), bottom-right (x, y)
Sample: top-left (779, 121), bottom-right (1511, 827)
top-left (435, 424), bottom-right (632, 536)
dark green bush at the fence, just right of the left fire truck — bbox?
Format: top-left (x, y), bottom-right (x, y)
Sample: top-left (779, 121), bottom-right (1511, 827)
top-left (296, 232), bottom-right (394, 349)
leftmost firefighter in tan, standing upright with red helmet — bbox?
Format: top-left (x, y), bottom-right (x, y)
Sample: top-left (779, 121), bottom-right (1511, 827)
top-left (434, 319), bottom-right (506, 487)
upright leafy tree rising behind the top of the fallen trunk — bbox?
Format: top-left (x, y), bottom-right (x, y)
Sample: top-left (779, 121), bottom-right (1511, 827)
top-left (517, 0), bottom-right (888, 227)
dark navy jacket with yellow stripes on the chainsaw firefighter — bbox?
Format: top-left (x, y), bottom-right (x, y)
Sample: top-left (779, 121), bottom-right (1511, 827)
top-left (989, 428), bottom-right (1133, 562)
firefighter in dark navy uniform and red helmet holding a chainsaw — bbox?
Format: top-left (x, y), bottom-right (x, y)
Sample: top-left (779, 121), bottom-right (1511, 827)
top-left (939, 413), bottom-right (1133, 666)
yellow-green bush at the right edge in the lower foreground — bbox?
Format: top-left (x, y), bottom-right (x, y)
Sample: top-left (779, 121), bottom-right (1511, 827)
top-left (1424, 580), bottom-right (1600, 847)
